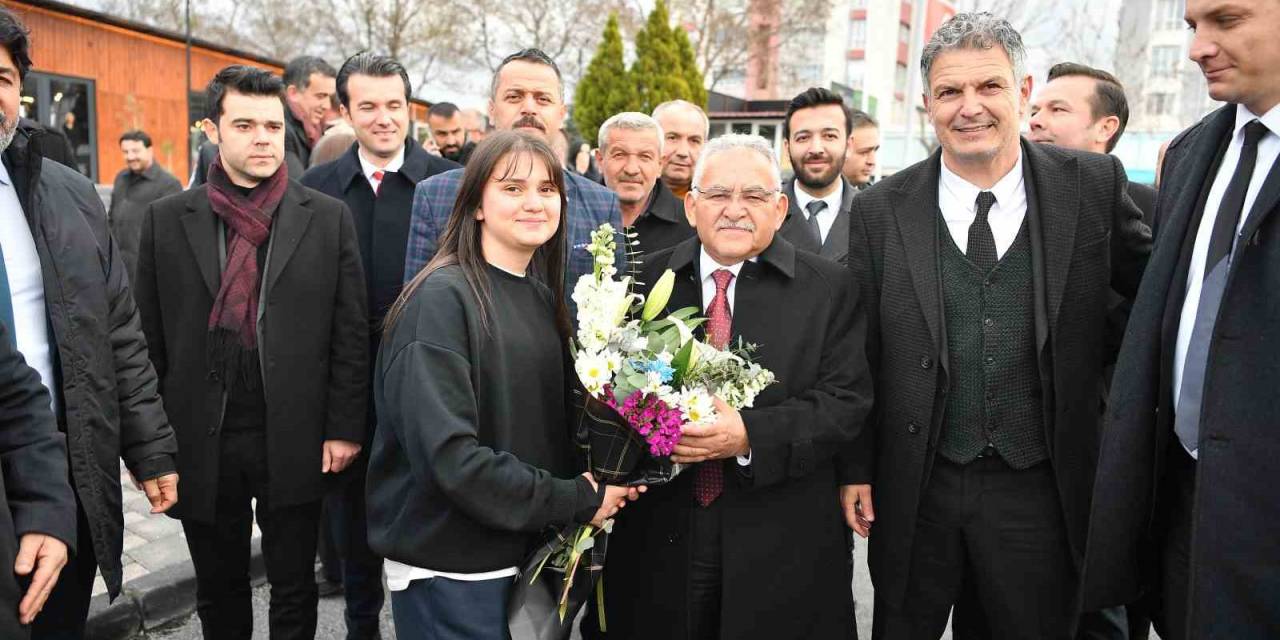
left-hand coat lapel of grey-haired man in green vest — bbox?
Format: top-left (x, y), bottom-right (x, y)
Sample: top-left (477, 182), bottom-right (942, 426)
top-left (893, 151), bottom-right (942, 348)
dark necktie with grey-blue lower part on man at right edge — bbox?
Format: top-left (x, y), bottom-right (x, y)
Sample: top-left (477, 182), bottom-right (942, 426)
top-left (1174, 120), bottom-right (1267, 452)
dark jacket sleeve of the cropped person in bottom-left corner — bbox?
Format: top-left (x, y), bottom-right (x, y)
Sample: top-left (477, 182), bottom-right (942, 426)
top-left (0, 324), bottom-right (77, 640)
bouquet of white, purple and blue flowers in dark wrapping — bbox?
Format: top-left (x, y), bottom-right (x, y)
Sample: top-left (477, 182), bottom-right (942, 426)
top-left (512, 224), bottom-right (774, 628)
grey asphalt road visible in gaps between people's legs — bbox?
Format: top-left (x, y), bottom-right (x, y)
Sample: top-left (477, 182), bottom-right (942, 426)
top-left (146, 540), bottom-right (911, 640)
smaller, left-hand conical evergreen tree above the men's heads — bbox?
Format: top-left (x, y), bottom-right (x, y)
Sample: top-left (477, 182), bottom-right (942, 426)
top-left (573, 14), bottom-right (639, 147)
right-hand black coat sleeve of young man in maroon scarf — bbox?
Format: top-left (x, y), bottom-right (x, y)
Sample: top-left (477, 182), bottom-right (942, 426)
top-left (324, 204), bottom-right (369, 443)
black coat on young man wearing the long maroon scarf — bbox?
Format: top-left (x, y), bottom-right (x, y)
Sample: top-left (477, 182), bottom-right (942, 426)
top-left (134, 180), bottom-right (369, 522)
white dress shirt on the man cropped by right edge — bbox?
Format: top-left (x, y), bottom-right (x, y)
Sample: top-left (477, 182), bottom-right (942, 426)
top-left (1174, 105), bottom-right (1280, 457)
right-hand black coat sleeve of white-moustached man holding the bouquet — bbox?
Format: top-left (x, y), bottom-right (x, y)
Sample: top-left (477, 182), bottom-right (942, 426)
top-left (742, 264), bottom-right (872, 488)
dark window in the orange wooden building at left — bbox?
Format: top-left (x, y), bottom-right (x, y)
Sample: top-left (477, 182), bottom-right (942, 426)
top-left (20, 72), bottom-right (97, 182)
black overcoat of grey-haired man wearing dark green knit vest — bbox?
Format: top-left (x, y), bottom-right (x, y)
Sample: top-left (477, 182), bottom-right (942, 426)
top-left (842, 141), bottom-right (1151, 608)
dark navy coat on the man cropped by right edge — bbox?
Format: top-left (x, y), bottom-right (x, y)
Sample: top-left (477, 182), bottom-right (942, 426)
top-left (1084, 104), bottom-right (1280, 639)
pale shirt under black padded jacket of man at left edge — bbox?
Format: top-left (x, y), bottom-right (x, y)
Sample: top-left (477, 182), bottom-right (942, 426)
top-left (0, 164), bottom-right (58, 407)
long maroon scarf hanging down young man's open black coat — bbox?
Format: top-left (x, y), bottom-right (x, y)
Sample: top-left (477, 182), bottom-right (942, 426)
top-left (207, 156), bottom-right (289, 381)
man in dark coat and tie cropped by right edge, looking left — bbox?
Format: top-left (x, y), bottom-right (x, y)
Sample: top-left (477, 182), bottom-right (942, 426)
top-left (1084, 0), bottom-right (1280, 640)
